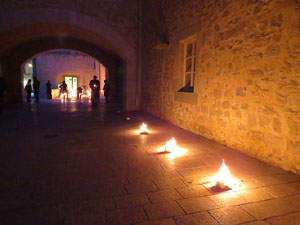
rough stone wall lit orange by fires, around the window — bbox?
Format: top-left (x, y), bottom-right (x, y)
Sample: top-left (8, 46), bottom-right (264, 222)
top-left (142, 0), bottom-right (300, 174)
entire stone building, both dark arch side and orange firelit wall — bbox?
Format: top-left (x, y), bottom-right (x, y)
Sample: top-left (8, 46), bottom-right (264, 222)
top-left (0, 0), bottom-right (300, 174)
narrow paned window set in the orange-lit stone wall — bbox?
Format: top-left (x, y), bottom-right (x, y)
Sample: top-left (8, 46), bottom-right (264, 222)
top-left (183, 39), bottom-right (197, 89)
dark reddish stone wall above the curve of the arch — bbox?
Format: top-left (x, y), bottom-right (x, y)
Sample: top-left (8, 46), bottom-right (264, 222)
top-left (0, 0), bottom-right (139, 46)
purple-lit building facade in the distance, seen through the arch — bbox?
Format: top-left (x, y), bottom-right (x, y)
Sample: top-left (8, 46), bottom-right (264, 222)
top-left (26, 50), bottom-right (106, 98)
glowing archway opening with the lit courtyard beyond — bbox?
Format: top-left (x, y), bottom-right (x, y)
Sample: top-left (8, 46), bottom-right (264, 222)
top-left (21, 49), bottom-right (108, 101)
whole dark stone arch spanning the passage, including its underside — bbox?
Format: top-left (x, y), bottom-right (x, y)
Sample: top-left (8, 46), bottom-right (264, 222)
top-left (0, 9), bottom-right (140, 110)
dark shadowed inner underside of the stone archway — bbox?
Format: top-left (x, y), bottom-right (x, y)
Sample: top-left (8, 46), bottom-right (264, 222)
top-left (14, 37), bottom-right (122, 104)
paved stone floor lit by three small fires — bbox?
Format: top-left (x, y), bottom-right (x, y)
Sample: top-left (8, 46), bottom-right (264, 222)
top-left (0, 102), bottom-right (300, 225)
